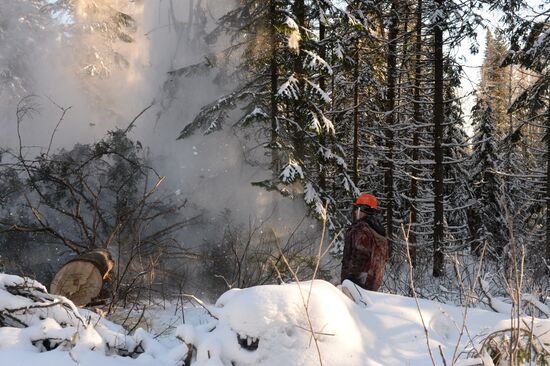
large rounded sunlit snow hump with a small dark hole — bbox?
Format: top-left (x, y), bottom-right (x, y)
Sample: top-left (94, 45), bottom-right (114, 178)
top-left (178, 281), bottom-right (364, 366)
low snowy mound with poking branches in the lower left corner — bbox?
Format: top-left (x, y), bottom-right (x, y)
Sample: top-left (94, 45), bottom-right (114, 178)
top-left (0, 273), bottom-right (181, 366)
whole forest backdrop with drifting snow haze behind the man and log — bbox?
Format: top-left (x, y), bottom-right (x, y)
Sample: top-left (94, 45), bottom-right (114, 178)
top-left (0, 0), bottom-right (550, 312)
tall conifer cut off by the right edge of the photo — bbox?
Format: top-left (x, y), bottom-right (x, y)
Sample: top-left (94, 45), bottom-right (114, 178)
top-left (500, 1), bottom-right (550, 268)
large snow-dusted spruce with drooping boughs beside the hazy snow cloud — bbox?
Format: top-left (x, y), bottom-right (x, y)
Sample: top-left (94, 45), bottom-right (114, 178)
top-left (180, 0), bottom-right (356, 242)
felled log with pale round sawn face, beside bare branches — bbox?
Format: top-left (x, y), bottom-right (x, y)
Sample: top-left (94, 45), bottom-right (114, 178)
top-left (50, 249), bottom-right (113, 306)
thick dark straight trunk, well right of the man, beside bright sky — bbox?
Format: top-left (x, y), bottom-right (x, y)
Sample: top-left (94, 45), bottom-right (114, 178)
top-left (433, 0), bottom-right (445, 277)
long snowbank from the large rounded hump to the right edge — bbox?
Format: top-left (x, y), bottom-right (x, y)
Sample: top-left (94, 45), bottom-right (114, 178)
top-left (177, 281), bottom-right (550, 366)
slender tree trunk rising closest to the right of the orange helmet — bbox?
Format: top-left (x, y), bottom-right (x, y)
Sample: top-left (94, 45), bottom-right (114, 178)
top-left (384, 0), bottom-right (399, 249)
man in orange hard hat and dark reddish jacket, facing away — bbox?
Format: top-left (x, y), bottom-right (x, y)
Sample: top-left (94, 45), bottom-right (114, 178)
top-left (341, 193), bottom-right (389, 291)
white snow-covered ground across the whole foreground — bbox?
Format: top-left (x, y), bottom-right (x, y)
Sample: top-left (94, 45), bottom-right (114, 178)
top-left (0, 274), bottom-right (550, 366)
